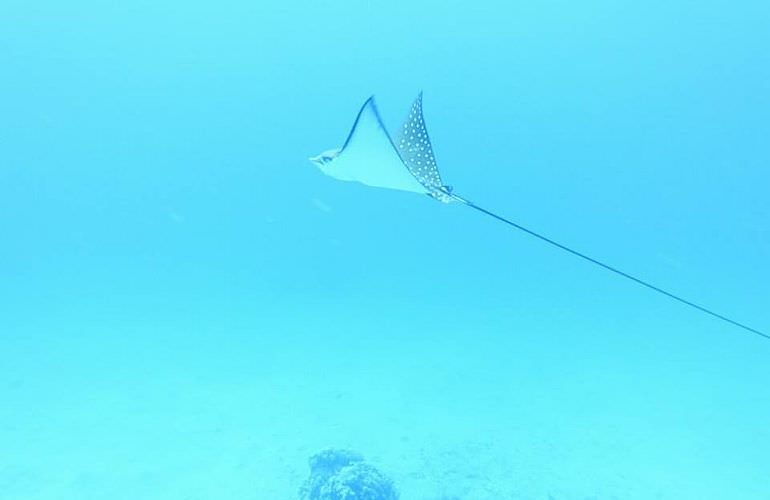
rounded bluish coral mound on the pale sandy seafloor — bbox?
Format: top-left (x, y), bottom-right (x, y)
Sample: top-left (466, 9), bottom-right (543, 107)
top-left (299, 449), bottom-right (398, 500)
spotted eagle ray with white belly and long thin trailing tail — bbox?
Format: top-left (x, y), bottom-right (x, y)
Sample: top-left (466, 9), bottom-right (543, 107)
top-left (310, 92), bottom-right (770, 340)
